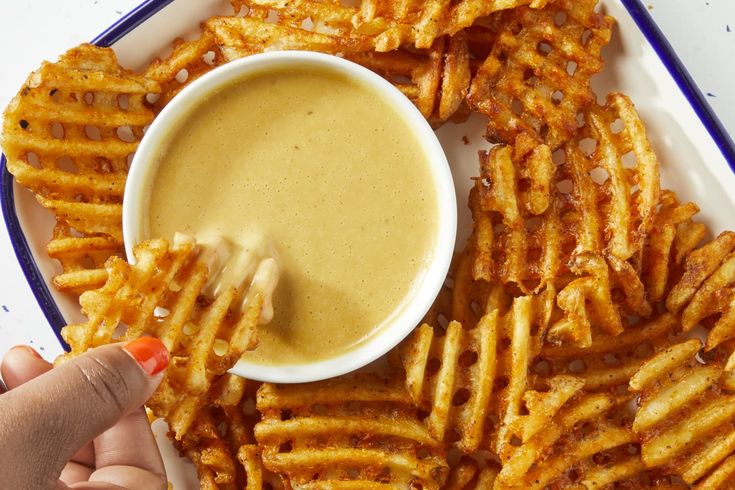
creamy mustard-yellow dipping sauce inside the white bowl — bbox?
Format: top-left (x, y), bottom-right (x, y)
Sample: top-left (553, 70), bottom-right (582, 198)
top-left (146, 66), bottom-right (439, 365)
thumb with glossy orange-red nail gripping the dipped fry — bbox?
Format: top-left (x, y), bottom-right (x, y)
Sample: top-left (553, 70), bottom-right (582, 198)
top-left (0, 337), bottom-right (168, 488)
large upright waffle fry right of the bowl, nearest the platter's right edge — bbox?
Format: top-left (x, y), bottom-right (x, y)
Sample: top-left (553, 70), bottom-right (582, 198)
top-left (470, 94), bottom-right (659, 294)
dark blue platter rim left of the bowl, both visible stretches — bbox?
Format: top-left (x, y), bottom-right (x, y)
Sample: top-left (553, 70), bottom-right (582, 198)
top-left (0, 0), bottom-right (173, 350)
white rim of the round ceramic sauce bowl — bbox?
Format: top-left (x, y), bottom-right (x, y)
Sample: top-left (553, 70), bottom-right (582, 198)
top-left (123, 51), bottom-right (457, 383)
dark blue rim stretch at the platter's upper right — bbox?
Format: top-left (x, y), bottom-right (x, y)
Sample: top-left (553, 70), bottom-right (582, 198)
top-left (622, 0), bottom-right (735, 172)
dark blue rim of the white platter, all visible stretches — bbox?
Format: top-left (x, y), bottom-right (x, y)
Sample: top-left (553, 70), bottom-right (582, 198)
top-left (0, 0), bottom-right (735, 349)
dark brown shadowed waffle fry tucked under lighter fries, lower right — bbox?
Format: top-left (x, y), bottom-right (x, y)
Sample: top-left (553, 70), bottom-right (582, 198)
top-left (532, 313), bottom-right (679, 391)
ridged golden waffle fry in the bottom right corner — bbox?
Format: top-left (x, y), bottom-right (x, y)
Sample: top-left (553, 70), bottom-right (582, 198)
top-left (630, 340), bottom-right (735, 489)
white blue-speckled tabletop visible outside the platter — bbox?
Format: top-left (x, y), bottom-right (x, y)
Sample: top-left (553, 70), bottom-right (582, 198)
top-left (0, 0), bottom-right (735, 360)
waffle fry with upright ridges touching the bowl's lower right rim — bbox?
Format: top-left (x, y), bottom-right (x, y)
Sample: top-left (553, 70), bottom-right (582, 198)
top-left (401, 295), bottom-right (553, 454)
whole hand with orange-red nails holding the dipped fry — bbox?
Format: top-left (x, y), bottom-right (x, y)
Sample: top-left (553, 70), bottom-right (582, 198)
top-left (0, 337), bottom-right (168, 490)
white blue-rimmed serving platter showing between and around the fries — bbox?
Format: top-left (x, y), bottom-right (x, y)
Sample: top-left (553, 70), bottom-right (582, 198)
top-left (0, 0), bottom-right (735, 484)
